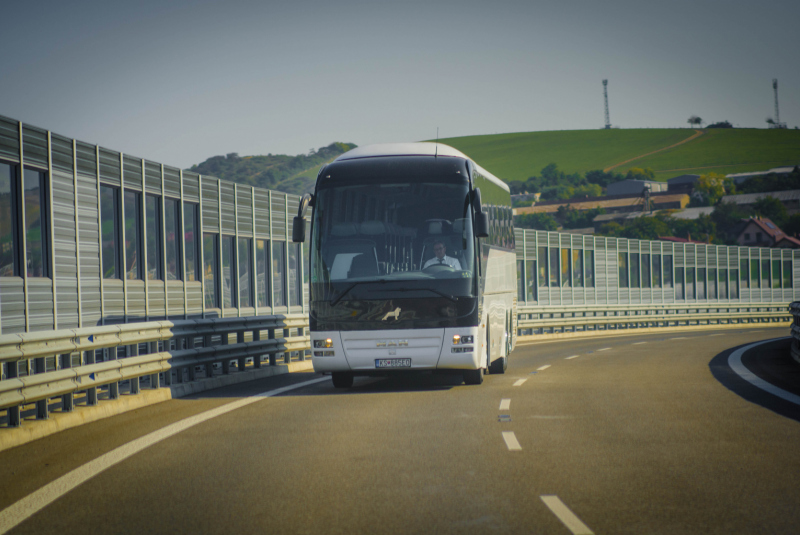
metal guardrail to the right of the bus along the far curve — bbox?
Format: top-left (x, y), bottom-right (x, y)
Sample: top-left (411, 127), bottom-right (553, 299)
top-left (517, 303), bottom-right (797, 336)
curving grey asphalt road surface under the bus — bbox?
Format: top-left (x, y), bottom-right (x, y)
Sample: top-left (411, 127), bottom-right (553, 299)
top-left (0, 328), bottom-right (800, 534)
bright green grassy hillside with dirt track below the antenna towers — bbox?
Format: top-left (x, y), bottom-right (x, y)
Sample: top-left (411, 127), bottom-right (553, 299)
top-left (440, 128), bottom-right (800, 181)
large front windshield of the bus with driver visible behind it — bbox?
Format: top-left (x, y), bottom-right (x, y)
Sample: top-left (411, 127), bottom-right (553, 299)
top-left (311, 179), bottom-right (475, 301)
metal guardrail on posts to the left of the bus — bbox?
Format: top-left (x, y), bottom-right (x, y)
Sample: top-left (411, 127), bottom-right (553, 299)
top-left (0, 314), bottom-right (310, 427)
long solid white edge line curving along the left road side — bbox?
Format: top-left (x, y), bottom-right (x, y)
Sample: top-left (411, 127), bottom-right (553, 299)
top-left (0, 377), bottom-right (329, 535)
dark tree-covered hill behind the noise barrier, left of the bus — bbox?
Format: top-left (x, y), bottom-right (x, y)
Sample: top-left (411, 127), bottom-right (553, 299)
top-left (190, 142), bottom-right (355, 194)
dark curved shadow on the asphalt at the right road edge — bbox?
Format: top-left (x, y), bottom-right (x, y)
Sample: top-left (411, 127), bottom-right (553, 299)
top-left (708, 338), bottom-right (800, 422)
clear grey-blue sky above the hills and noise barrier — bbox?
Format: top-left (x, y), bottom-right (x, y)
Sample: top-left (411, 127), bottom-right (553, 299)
top-left (0, 0), bottom-right (800, 167)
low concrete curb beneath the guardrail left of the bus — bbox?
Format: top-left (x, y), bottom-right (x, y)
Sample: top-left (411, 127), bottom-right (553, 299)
top-left (0, 360), bottom-right (313, 451)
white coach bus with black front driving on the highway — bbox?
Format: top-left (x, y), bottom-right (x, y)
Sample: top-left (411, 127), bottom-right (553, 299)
top-left (292, 143), bottom-right (517, 388)
